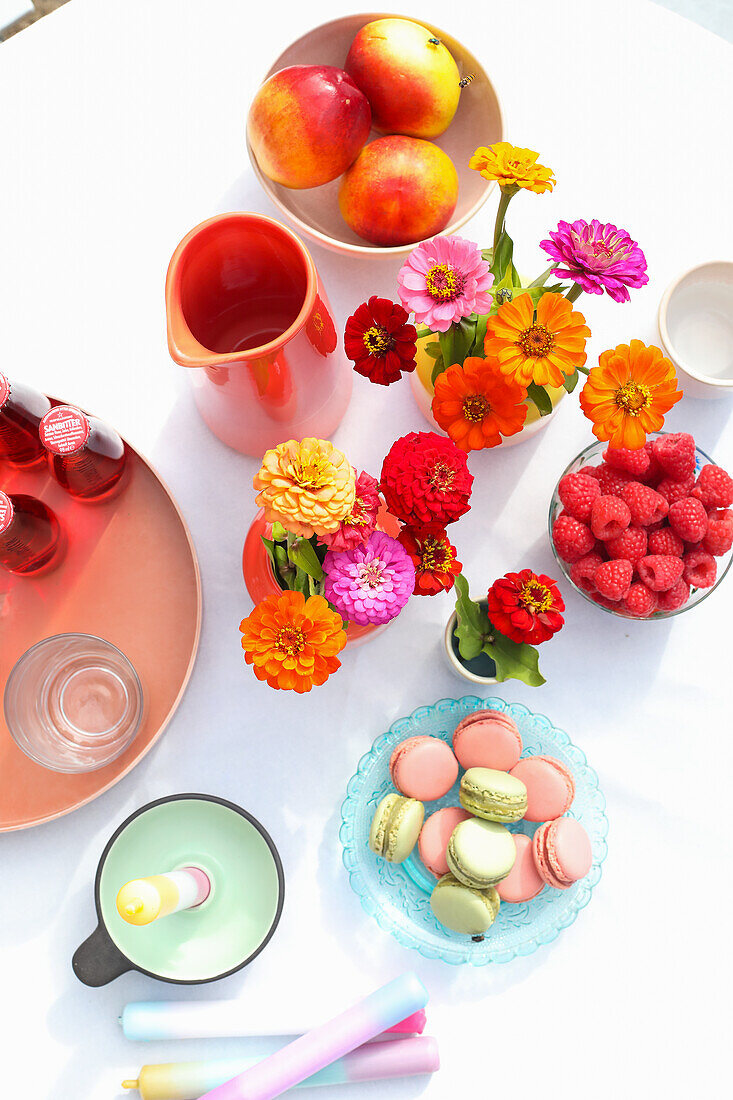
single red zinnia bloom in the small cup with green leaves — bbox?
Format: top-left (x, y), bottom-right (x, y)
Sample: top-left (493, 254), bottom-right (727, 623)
top-left (489, 569), bottom-right (565, 646)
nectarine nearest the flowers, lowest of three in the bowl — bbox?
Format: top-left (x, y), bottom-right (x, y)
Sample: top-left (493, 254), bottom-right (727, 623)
top-left (339, 134), bottom-right (458, 245)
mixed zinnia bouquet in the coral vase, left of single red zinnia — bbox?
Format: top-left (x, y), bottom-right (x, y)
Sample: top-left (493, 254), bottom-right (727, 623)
top-left (240, 432), bottom-right (473, 692)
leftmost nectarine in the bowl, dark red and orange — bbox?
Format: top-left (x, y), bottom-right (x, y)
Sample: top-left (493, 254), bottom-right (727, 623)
top-left (247, 65), bottom-right (371, 188)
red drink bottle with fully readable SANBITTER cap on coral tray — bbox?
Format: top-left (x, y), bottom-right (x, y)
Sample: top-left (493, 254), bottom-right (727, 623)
top-left (40, 405), bottom-right (128, 501)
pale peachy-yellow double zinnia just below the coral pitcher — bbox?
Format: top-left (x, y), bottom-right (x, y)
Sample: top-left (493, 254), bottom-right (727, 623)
top-left (253, 438), bottom-right (355, 538)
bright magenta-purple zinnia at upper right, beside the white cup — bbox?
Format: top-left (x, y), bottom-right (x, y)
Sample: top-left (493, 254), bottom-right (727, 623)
top-left (540, 218), bottom-right (649, 301)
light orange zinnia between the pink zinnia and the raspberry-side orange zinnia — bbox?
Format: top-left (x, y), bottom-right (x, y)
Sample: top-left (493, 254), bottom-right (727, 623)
top-left (483, 290), bottom-right (590, 386)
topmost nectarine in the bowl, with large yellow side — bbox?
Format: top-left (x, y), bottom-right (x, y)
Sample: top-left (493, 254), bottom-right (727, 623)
top-left (343, 19), bottom-right (461, 138)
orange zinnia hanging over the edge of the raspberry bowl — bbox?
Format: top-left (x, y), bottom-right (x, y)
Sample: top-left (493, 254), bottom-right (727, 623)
top-left (580, 340), bottom-right (682, 451)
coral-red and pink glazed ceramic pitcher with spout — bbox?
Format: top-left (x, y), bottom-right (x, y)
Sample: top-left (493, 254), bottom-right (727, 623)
top-left (165, 213), bottom-right (352, 457)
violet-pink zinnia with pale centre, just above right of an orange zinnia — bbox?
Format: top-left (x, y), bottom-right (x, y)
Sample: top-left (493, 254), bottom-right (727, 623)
top-left (324, 531), bottom-right (415, 626)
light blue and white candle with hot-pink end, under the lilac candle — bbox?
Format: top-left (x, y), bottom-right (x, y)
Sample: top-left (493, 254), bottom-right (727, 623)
top-left (120, 997), bottom-right (426, 1042)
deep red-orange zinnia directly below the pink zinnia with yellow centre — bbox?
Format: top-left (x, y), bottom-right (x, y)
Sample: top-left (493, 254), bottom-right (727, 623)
top-left (433, 355), bottom-right (527, 451)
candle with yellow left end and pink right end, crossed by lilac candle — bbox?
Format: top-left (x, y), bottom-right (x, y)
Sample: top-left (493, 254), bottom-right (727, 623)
top-left (122, 1035), bottom-right (440, 1100)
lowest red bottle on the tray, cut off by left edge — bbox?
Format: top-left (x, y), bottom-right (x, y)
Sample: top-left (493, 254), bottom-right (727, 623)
top-left (0, 492), bottom-right (62, 575)
